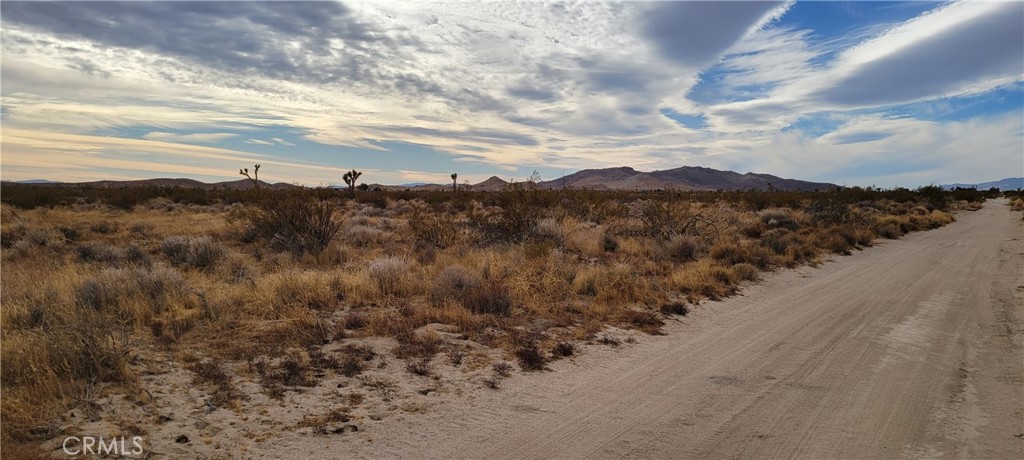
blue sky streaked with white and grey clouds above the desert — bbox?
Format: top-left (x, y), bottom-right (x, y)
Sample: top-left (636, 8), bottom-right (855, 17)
top-left (0, 0), bottom-right (1024, 187)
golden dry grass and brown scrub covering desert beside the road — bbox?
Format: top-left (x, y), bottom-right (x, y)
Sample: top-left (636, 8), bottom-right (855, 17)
top-left (0, 191), bottom-right (966, 457)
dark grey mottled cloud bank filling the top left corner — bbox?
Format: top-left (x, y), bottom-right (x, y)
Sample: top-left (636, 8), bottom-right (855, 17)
top-left (3, 2), bottom-right (395, 82)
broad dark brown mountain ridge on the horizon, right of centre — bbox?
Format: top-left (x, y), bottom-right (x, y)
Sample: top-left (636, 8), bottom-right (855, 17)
top-left (540, 166), bottom-right (839, 191)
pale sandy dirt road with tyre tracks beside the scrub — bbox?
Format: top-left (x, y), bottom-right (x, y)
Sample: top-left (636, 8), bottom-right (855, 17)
top-left (329, 201), bottom-right (1024, 459)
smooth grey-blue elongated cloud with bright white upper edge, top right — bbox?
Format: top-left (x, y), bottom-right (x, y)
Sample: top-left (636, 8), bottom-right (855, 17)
top-left (809, 2), bottom-right (1024, 107)
